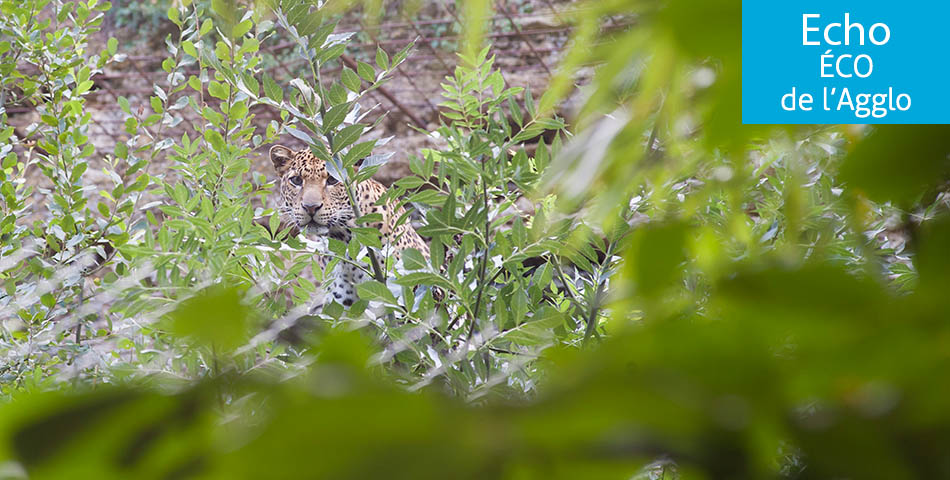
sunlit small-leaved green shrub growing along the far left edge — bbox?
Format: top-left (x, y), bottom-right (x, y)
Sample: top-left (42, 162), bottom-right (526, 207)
top-left (0, 0), bottom-right (125, 394)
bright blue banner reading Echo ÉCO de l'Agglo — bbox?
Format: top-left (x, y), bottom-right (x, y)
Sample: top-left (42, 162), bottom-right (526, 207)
top-left (742, 0), bottom-right (950, 124)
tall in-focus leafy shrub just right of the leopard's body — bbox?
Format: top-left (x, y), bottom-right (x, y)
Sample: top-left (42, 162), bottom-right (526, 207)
top-left (367, 48), bottom-right (623, 397)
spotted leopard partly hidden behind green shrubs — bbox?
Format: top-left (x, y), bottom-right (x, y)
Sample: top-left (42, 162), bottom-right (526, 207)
top-left (269, 145), bottom-right (429, 307)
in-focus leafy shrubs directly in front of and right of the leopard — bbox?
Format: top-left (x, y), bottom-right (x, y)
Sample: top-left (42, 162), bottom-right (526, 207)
top-left (200, 2), bottom-right (608, 395)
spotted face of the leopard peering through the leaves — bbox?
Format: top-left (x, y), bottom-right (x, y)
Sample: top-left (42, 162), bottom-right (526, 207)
top-left (270, 145), bottom-right (353, 234)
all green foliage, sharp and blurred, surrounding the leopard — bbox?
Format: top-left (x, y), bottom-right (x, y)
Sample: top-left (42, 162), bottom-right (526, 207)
top-left (0, 0), bottom-right (950, 479)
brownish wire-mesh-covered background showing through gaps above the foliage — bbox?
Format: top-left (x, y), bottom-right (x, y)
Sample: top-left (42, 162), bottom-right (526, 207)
top-left (7, 0), bottom-right (608, 191)
